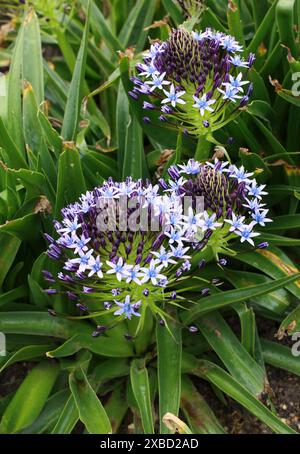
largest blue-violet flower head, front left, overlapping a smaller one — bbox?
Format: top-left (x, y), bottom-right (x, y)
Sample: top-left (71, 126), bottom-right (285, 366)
top-left (44, 178), bottom-right (189, 334)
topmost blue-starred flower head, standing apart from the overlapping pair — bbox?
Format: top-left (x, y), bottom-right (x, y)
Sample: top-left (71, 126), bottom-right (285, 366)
top-left (130, 26), bottom-right (254, 136)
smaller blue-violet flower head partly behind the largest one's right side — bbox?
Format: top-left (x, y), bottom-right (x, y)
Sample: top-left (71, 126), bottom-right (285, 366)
top-left (167, 159), bottom-right (271, 255)
